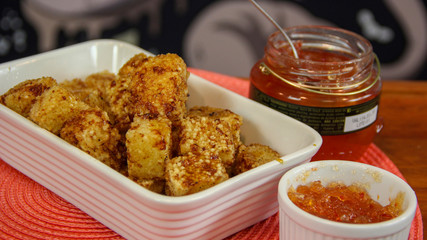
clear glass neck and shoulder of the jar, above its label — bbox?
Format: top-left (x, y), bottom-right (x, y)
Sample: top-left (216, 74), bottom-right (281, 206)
top-left (260, 26), bottom-right (380, 95)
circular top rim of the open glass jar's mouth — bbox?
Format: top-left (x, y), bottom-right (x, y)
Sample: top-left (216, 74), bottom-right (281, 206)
top-left (267, 25), bottom-right (373, 64)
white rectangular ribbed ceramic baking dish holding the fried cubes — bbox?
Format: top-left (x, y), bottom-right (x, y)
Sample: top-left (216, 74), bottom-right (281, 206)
top-left (0, 40), bottom-right (322, 240)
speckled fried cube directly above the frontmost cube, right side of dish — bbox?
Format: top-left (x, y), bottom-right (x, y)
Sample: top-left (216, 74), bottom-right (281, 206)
top-left (179, 116), bottom-right (236, 170)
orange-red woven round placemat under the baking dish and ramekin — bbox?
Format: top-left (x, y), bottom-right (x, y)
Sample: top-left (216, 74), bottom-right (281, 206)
top-left (0, 69), bottom-right (423, 240)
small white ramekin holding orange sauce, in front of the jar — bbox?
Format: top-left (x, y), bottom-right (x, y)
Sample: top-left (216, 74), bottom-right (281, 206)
top-left (278, 160), bottom-right (417, 240)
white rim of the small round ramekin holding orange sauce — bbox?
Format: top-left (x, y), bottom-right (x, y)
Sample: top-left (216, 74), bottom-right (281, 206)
top-left (278, 160), bottom-right (417, 237)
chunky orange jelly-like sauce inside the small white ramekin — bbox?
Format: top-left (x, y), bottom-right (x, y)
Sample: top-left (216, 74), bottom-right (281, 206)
top-left (288, 181), bottom-right (403, 223)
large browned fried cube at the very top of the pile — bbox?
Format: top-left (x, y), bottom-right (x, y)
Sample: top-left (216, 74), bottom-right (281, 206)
top-left (108, 54), bottom-right (189, 133)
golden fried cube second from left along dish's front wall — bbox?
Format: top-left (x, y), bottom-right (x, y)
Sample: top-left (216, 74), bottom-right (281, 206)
top-left (29, 85), bottom-right (90, 135)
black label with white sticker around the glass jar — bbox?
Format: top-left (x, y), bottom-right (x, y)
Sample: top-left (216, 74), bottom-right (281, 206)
top-left (250, 84), bottom-right (379, 135)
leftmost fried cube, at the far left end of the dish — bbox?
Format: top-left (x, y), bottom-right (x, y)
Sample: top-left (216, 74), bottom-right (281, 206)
top-left (0, 77), bottom-right (57, 117)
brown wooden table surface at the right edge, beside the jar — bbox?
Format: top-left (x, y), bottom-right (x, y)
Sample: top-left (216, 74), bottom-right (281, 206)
top-left (374, 80), bottom-right (427, 236)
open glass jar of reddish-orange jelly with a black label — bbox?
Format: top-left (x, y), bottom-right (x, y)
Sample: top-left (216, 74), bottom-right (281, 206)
top-left (250, 26), bottom-right (382, 161)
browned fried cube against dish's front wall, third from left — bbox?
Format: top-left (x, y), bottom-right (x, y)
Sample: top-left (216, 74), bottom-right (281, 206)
top-left (59, 108), bottom-right (122, 171)
